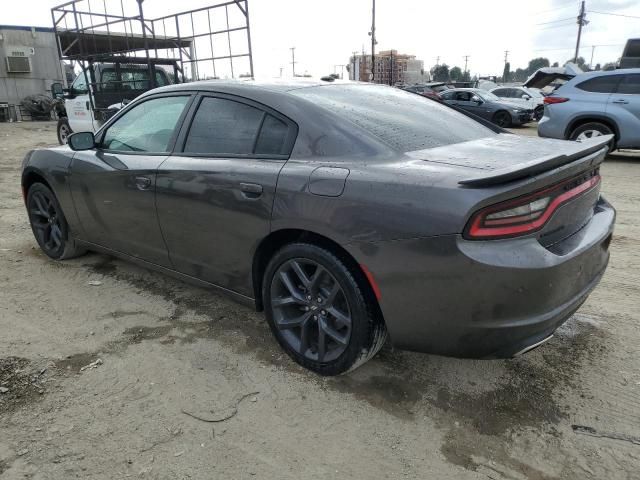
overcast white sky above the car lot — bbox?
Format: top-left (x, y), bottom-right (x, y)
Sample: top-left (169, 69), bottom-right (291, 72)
top-left (0, 0), bottom-right (640, 77)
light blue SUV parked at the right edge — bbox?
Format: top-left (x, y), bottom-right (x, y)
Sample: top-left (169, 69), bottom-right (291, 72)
top-left (538, 68), bottom-right (640, 149)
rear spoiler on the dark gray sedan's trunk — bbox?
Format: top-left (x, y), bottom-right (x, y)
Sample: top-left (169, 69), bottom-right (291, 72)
top-left (458, 135), bottom-right (613, 187)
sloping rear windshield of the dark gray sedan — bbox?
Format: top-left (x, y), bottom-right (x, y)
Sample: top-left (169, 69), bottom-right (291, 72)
top-left (290, 85), bottom-right (496, 152)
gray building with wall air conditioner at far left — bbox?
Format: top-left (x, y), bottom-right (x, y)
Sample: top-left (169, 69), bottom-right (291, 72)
top-left (0, 25), bottom-right (65, 110)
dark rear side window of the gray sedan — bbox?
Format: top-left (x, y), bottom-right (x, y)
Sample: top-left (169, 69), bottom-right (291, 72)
top-left (184, 97), bottom-right (289, 155)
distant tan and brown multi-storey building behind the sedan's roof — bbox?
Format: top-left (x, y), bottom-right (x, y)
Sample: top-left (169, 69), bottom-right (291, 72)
top-left (349, 50), bottom-right (429, 85)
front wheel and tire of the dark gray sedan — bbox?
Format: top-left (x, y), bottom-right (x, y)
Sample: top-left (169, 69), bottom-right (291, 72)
top-left (27, 183), bottom-right (86, 260)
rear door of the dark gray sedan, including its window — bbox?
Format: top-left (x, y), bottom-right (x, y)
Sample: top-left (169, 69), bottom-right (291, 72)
top-left (156, 94), bottom-right (297, 297)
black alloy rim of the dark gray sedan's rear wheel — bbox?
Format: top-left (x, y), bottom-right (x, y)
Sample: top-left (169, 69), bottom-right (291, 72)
top-left (270, 258), bottom-right (352, 362)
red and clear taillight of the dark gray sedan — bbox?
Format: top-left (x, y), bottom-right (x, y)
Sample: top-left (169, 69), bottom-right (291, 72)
top-left (465, 171), bottom-right (600, 240)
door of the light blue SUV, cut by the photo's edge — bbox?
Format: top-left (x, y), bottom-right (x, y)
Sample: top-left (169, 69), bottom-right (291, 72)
top-left (607, 73), bottom-right (640, 148)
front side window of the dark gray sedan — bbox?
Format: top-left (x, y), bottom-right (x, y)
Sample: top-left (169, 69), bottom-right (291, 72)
top-left (102, 96), bottom-right (189, 153)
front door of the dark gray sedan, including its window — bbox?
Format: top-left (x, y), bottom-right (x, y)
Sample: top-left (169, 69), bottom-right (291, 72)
top-left (71, 94), bottom-right (191, 267)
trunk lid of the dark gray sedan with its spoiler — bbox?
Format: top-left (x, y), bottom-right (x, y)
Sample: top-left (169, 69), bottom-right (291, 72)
top-left (407, 134), bottom-right (613, 247)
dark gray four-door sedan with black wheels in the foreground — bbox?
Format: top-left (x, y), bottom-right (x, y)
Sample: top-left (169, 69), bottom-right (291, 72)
top-left (22, 81), bottom-right (615, 375)
